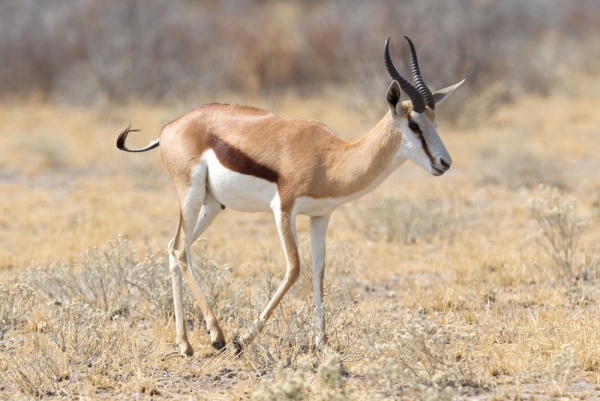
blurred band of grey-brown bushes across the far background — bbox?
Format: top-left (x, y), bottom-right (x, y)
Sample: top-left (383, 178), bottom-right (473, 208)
top-left (0, 0), bottom-right (600, 110)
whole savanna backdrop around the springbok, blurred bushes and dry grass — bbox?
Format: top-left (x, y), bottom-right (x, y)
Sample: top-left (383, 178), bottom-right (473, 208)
top-left (0, 0), bottom-right (600, 400)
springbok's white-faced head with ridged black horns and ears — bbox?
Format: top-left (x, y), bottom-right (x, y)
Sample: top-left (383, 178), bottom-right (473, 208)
top-left (384, 36), bottom-right (464, 176)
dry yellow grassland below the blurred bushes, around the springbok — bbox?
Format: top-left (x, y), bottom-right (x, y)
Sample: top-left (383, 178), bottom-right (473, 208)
top-left (0, 76), bottom-right (600, 400)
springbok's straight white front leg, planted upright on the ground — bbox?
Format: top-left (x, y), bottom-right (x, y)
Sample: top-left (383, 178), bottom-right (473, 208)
top-left (310, 215), bottom-right (331, 351)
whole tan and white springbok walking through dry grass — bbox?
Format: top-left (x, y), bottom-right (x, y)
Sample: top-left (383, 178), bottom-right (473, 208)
top-left (117, 37), bottom-right (464, 356)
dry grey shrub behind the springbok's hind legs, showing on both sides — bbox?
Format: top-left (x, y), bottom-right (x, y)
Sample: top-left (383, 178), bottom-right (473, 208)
top-left (25, 236), bottom-right (238, 334)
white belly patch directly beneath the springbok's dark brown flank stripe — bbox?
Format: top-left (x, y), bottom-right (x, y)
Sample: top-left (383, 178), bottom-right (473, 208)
top-left (202, 150), bottom-right (277, 212)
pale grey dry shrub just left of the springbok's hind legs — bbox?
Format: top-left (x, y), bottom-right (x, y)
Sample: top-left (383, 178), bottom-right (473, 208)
top-left (24, 236), bottom-right (182, 320)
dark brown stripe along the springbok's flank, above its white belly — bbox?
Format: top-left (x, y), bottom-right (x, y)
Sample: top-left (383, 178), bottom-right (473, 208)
top-left (208, 135), bottom-right (279, 183)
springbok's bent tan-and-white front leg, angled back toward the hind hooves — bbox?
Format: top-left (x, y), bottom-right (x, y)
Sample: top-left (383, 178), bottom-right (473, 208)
top-left (234, 210), bottom-right (300, 351)
